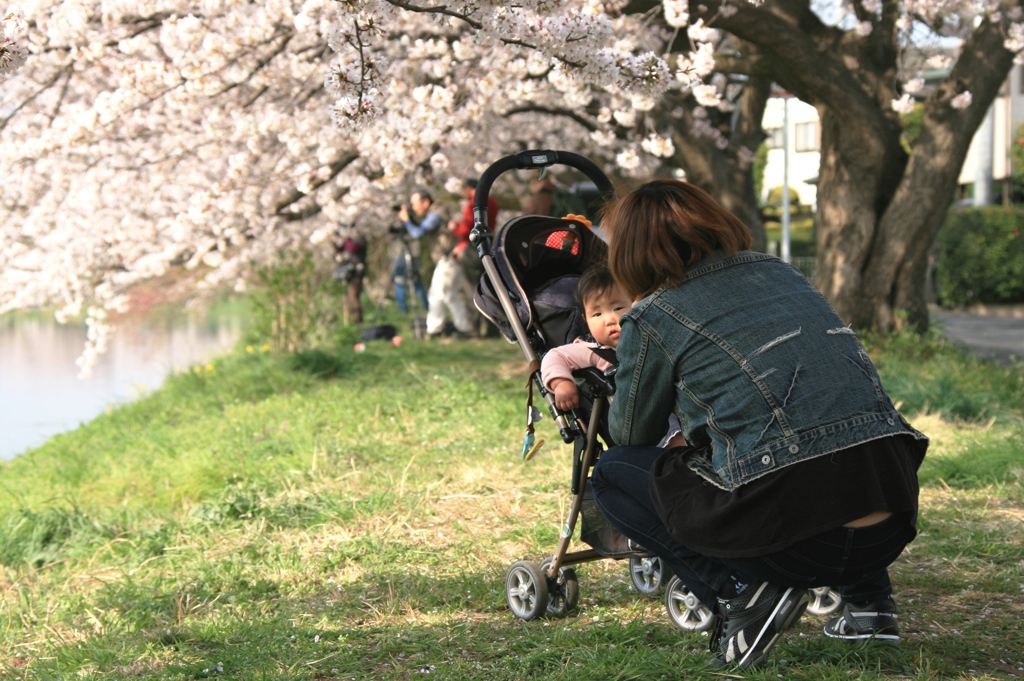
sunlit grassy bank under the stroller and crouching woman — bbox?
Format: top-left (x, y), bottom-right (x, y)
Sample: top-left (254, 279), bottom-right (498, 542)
top-left (0, 327), bottom-right (1024, 681)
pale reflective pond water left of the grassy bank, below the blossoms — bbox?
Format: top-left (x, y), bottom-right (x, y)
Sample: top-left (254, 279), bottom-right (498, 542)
top-left (0, 313), bottom-right (243, 460)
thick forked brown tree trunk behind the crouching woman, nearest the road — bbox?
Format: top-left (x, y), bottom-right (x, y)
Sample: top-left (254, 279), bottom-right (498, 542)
top-left (704, 0), bottom-right (1013, 330)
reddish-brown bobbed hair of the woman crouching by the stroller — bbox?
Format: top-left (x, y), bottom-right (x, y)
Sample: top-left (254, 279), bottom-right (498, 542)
top-left (601, 179), bottom-right (753, 299)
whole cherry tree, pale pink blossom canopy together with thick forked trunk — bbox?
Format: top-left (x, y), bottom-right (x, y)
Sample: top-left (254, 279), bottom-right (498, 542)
top-left (0, 0), bottom-right (1022, 367)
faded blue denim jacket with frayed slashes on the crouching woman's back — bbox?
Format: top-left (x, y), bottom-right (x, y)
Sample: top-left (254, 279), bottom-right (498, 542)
top-left (609, 251), bottom-right (927, 491)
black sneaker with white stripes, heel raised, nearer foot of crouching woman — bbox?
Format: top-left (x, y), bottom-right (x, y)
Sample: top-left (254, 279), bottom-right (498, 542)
top-left (711, 582), bottom-right (810, 668)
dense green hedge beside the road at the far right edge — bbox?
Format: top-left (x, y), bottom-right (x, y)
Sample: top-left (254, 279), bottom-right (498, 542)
top-left (936, 206), bottom-right (1024, 307)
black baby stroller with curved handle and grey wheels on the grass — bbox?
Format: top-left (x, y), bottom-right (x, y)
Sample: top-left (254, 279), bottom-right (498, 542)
top-left (470, 151), bottom-right (841, 631)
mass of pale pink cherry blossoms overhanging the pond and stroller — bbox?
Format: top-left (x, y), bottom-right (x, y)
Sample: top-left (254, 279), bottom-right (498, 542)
top-left (0, 0), bottom-right (745, 368)
